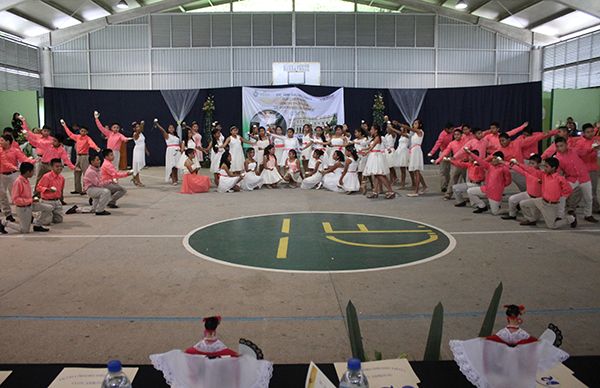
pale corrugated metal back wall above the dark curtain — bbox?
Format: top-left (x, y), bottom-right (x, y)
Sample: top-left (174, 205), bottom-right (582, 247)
top-left (52, 13), bottom-right (531, 89)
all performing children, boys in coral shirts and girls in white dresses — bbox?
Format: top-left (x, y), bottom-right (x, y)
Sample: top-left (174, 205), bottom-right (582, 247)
top-left (0, 112), bottom-right (600, 233)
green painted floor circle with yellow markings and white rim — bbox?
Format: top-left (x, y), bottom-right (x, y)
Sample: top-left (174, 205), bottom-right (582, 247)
top-left (184, 212), bottom-right (456, 272)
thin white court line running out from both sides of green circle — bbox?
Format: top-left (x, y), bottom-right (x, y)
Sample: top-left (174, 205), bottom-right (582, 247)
top-left (0, 229), bottom-right (600, 240)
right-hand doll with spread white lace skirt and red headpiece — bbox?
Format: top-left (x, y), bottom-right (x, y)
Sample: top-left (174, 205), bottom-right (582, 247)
top-left (450, 305), bottom-right (569, 388)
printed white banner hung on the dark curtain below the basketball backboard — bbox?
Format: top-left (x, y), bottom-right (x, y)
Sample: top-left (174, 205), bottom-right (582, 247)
top-left (242, 87), bottom-right (346, 135)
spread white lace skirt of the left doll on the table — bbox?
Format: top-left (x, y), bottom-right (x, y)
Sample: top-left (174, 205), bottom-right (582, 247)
top-left (150, 350), bottom-right (273, 388)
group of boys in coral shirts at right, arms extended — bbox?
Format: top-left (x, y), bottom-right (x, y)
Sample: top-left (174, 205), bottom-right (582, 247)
top-left (428, 122), bottom-right (600, 229)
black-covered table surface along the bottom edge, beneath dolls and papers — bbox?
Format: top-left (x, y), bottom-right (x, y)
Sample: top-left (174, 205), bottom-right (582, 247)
top-left (0, 356), bottom-right (600, 388)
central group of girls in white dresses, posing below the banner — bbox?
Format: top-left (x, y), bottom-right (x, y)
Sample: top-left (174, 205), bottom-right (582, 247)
top-left (171, 116), bottom-right (427, 199)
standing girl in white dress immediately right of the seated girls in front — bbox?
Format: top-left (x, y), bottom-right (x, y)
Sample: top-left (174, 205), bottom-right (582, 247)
top-left (363, 124), bottom-right (396, 199)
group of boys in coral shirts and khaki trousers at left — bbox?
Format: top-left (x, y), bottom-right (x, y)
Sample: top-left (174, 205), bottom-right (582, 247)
top-left (0, 112), bottom-right (134, 234)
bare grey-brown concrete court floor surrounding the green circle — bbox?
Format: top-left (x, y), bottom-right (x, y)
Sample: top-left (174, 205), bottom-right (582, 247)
top-left (0, 168), bottom-right (600, 363)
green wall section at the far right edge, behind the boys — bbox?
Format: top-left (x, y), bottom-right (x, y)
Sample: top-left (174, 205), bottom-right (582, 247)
top-left (551, 88), bottom-right (600, 129)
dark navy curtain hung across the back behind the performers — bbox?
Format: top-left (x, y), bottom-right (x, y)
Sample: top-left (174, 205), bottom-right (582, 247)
top-left (44, 82), bottom-right (548, 165)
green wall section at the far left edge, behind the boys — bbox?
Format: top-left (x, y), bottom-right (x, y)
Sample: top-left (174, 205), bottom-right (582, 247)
top-left (0, 90), bottom-right (40, 130)
